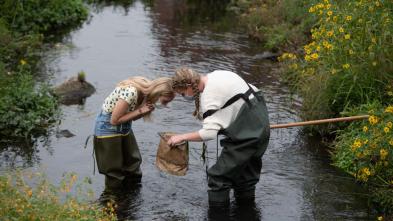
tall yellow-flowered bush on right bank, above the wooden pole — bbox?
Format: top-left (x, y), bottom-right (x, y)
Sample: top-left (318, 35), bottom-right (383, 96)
top-left (282, 0), bottom-right (393, 119)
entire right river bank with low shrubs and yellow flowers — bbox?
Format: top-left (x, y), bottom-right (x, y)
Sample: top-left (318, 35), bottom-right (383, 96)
top-left (232, 0), bottom-right (393, 218)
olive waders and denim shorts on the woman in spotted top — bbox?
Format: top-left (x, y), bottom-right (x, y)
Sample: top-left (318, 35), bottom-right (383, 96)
top-left (94, 113), bottom-right (142, 192)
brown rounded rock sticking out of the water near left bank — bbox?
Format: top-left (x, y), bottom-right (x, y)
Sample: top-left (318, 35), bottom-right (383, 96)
top-left (54, 72), bottom-right (95, 105)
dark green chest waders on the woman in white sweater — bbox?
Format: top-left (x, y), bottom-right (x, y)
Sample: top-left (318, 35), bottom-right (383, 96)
top-left (203, 85), bottom-right (270, 205)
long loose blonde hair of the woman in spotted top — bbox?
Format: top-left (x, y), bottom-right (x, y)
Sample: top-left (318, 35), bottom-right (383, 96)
top-left (117, 76), bottom-right (175, 120)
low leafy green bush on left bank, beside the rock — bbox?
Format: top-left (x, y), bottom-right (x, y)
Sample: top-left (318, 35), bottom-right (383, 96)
top-left (0, 66), bottom-right (58, 140)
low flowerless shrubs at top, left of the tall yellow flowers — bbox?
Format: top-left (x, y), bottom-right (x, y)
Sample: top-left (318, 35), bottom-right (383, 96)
top-left (228, 0), bottom-right (315, 50)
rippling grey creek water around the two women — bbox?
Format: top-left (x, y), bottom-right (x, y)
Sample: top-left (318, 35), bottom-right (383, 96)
top-left (0, 0), bottom-right (372, 220)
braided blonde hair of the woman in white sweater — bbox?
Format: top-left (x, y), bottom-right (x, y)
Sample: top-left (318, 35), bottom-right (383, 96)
top-left (172, 67), bottom-right (202, 120)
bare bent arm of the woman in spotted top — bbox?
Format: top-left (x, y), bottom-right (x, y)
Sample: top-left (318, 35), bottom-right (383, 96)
top-left (111, 99), bottom-right (154, 125)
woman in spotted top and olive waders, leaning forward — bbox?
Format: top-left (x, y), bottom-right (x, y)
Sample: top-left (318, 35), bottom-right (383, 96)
top-left (94, 77), bottom-right (175, 190)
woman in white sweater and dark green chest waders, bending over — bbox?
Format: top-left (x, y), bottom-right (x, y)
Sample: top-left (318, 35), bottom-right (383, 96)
top-left (168, 68), bottom-right (270, 205)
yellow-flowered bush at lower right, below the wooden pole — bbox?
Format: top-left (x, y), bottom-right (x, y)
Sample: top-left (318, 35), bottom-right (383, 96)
top-left (332, 103), bottom-right (393, 213)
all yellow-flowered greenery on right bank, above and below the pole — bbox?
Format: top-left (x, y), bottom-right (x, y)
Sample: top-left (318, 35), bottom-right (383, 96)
top-left (280, 0), bottom-right (393, 214)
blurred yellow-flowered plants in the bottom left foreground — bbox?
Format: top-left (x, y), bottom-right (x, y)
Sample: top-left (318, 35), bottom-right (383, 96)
top-left (0, 172), bottom-right (116, 221)
